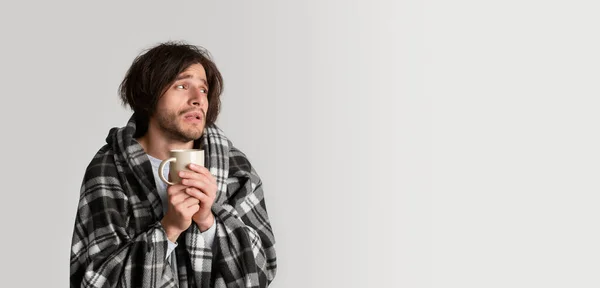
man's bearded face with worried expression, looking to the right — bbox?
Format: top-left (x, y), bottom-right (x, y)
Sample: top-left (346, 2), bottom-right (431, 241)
top-left (150, 64), bottom-right (209, 142)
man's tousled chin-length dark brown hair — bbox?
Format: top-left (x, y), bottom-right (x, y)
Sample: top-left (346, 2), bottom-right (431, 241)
top-left (119, 41), bottom-right (223, 136)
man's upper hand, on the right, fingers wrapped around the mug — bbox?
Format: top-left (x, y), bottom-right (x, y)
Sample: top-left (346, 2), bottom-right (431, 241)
top-left (179, 164), bottom-right (217, 232)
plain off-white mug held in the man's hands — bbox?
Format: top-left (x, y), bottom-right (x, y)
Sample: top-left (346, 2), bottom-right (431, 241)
top-left (158, 149), bottom-right (204, 185)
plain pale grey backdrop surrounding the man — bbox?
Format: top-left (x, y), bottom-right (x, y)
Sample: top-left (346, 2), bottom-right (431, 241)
top-left (0, 0), bottom-right (600, 287)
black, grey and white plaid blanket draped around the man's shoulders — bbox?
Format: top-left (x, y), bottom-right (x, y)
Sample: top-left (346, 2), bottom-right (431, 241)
top-left (70, 116), bottom-right (277, 288)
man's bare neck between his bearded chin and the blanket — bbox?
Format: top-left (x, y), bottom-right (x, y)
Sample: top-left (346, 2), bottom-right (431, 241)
top-left (137, 127), bottom-right (194, 160)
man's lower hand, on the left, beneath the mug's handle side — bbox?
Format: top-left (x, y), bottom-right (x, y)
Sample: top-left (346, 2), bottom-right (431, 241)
top-left (161, 184), bottom-right (200, 243)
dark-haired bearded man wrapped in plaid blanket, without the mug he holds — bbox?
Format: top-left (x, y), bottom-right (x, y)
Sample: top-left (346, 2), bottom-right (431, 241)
top-left (70, 42), bottom-right (277, 288)
